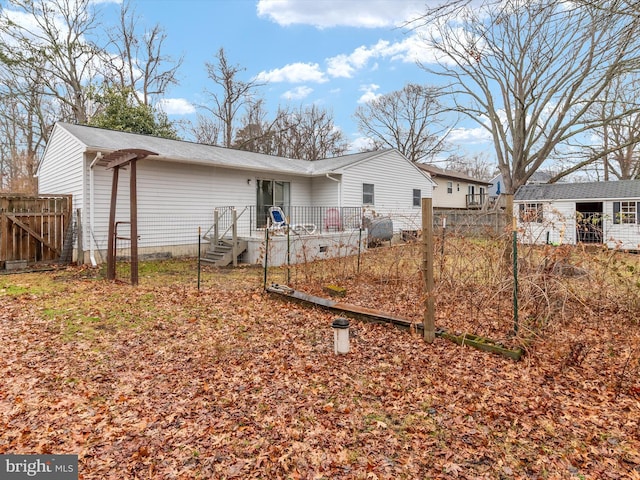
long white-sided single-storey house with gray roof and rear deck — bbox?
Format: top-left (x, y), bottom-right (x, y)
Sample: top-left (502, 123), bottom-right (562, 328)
top-left (38, 123), bottom-right (433, 264)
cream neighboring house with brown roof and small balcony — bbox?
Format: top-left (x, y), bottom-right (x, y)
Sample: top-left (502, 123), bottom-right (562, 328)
top-left (417, 163), bottom-right (491, 209)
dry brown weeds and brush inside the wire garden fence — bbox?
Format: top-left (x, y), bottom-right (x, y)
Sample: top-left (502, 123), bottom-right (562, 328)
top-left (282, 235), bottom-right (640, 368)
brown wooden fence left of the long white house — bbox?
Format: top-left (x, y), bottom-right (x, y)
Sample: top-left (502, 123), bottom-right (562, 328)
top-left (0, 195), bottom-right (73, 269)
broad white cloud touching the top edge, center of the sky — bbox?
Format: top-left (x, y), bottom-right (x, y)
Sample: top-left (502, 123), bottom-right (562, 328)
top-left (257, 0), bottom-right (425, 28)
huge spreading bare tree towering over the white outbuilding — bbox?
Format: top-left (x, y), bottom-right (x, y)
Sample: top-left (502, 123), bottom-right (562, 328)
top-left (416, 0), bottom-right (640, 193)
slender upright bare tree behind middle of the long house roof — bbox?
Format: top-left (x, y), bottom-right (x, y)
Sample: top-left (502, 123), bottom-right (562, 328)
top-left (204, 48), bottom-right (262, 147)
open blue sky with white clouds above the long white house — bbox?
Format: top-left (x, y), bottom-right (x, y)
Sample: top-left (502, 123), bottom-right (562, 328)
top-left (95, 0), bottom-right (486, 153)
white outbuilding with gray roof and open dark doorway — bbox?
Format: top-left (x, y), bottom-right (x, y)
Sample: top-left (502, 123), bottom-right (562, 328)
top-left (513, 180), bottom-right (640, 250)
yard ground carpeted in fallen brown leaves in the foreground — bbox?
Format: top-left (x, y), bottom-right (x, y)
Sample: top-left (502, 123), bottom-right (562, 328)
top-left (0, 249), bottom-right (640, 479)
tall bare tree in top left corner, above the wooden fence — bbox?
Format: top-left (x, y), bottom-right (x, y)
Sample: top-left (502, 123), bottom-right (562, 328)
top-left (0, 0), bottom-right (102, 123)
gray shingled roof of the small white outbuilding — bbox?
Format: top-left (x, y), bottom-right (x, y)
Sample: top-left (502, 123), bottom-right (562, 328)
top-left (513, 180), bottom-right (640, 201)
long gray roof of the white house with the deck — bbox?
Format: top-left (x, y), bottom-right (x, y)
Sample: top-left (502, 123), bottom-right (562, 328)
top-left (56, 122), bottom-right (392, 176)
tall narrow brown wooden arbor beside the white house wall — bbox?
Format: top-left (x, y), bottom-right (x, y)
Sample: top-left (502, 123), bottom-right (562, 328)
top-left (102, 148), bottom-right (157, 285)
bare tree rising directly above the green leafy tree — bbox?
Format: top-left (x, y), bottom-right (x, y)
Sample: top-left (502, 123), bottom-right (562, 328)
top-left (106, 0), bottom-right (183, 105)
